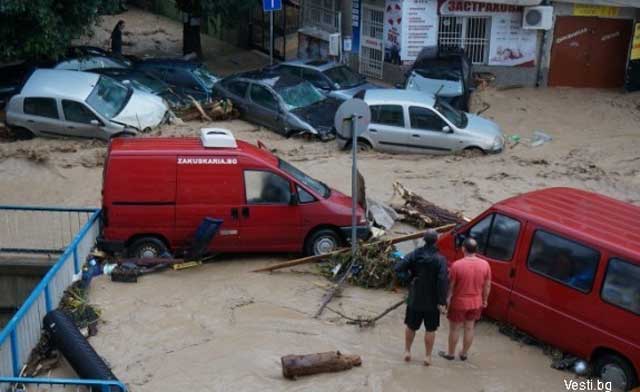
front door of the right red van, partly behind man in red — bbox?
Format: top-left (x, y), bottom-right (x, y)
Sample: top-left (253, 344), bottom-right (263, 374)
top-left (459, 211), bottom-right (524, 321)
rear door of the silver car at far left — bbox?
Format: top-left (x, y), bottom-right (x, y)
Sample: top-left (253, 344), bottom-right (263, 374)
top-left (18, 97), bottom-right (68, 136)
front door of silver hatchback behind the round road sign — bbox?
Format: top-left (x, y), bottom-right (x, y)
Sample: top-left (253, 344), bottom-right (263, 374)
top-left (404, 106), bottom-right (455, 154)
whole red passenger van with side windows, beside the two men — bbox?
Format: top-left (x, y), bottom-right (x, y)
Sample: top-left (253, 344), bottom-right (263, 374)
top-left (439, 188), bottom-right (640, 390)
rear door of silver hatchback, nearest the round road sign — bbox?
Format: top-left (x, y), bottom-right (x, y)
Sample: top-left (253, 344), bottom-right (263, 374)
top-left (364, 105), bottom-right (407, 152)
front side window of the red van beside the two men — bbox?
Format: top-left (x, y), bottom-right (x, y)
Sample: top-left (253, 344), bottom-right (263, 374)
top-left (469, 214), bottom-right (520, 261)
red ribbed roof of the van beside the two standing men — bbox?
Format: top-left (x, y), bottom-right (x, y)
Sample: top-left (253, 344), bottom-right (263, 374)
top-left (494, 188), bottom-right (640, 263)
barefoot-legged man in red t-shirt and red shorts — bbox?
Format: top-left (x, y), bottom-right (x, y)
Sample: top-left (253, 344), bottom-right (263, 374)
top-left (438, 238), bottom-right (491, 361)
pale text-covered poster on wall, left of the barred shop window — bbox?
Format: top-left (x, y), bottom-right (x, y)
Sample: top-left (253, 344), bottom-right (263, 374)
top-left (400, 0), bottom-right (438, 61)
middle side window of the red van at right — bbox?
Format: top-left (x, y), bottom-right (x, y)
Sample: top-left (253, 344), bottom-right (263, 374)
top-left (527, 230), bottom-right (600, 293)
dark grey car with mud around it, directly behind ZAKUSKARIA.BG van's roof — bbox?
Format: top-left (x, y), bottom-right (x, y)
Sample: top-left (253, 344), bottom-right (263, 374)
top-left (213, 71), bottom-right (340, 141)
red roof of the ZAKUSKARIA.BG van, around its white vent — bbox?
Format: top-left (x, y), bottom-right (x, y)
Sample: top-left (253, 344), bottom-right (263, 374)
top-left (109, 137), bottom-right (278, 164)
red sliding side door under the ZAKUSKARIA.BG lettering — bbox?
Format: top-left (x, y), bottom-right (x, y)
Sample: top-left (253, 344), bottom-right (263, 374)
top-left (176, 155), bottom-right (242, 252)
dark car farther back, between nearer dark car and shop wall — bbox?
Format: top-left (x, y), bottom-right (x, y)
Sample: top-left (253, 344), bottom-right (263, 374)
top-left (271, 60), bottom-right (384, 101)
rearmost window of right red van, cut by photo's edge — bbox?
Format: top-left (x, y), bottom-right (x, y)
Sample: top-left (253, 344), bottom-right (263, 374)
top-left (601, 258), bottom-right (640, 315)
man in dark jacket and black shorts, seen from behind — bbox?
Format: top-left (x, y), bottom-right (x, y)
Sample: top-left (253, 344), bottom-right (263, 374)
top-left (395, 230), bottom-right (449, 366)
